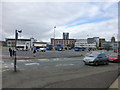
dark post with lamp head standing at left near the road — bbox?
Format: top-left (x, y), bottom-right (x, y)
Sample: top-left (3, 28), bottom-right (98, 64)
top-left (14, 30), bottom-right (22, 72)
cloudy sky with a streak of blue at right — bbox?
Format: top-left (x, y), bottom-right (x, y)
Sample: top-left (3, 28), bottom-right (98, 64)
top-left (0, 2), bottom-right (118, 42)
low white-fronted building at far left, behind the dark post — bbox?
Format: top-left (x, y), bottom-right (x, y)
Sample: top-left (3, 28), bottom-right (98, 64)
top-left (6, 38), bottom-right (36, 49)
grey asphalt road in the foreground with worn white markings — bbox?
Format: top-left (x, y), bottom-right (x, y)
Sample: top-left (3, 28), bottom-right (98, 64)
top-left (2, 57), bottom-right (119, 88)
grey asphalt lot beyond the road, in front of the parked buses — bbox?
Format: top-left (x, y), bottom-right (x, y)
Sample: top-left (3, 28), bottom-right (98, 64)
top-left (2, 48), bottom-right (87, 59)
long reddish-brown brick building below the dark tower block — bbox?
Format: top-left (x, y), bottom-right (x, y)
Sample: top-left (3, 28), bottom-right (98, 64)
top-left (51, 38), bottom-right (75, 48)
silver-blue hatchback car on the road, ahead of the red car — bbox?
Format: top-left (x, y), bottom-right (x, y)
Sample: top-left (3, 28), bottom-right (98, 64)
top-left (83, 52), bottom-right (109, 66)
